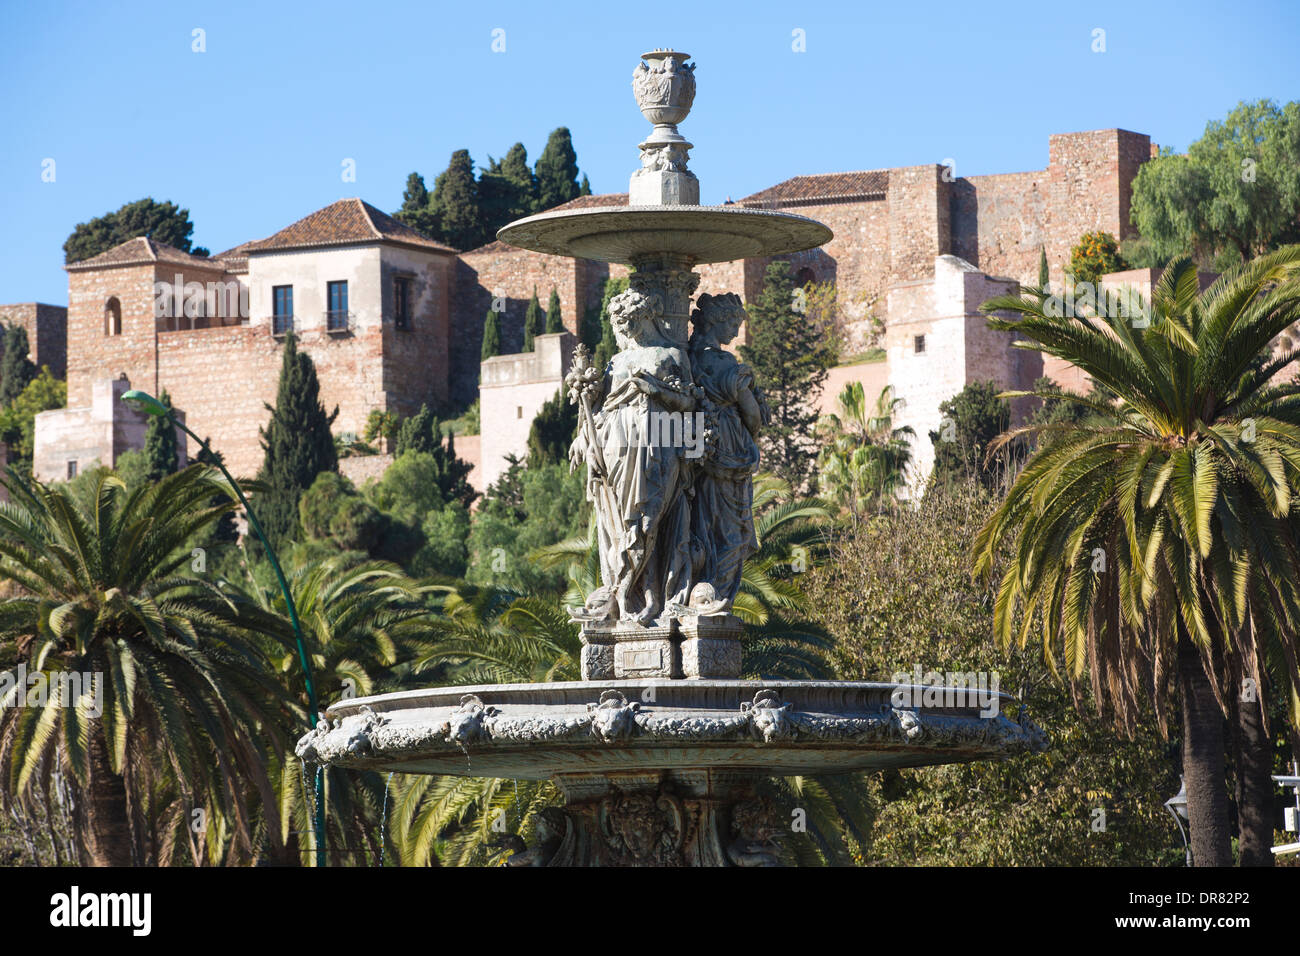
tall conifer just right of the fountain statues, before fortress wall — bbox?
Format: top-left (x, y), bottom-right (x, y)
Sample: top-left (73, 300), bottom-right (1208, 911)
top-left (740, 261), bottom-right (833, 490)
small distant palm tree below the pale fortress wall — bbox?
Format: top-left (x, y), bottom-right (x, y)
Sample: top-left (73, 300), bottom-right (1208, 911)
top-left (818, 381), bottom-right (917, 516)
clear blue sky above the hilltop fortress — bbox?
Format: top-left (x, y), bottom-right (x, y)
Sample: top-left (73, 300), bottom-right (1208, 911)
top-left (0, 0), bottom-right (1300, 303)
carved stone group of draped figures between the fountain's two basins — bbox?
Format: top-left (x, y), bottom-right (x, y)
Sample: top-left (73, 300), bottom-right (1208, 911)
top-left (566, 289), bottom-right (767, 626)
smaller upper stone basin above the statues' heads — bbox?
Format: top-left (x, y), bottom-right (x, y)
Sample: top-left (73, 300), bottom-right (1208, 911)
top-left (497, 206), bottom-right (833, 265)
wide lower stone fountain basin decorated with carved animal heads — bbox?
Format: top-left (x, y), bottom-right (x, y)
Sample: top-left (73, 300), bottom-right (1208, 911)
top-left (296, 680), bottom-right (1047, 779)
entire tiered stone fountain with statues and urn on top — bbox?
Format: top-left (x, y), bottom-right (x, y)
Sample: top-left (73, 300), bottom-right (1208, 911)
top-left (298, 49), bottom-right (1045, 866)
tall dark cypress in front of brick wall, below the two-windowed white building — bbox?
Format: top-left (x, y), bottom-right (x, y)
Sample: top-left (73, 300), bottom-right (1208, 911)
top-left (255, 333), bottom-right (338, 546)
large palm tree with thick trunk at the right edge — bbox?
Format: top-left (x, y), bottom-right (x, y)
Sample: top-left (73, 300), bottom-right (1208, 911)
top-left (974, 247), bottom-right (1300, 865)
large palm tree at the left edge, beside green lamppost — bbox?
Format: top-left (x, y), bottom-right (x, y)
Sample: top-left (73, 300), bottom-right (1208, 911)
top-left (0, 466), bottom-right (286, 865)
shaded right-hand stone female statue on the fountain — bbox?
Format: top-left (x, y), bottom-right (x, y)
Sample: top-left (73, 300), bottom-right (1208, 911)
top-left (690, 293), bottom-right (767, 607)
